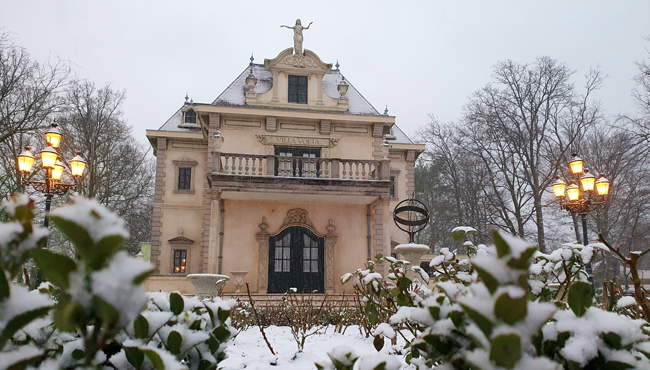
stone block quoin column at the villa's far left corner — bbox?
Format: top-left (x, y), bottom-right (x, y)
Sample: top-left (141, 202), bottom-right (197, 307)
top-left (151, 137), bottom-right (165, 273)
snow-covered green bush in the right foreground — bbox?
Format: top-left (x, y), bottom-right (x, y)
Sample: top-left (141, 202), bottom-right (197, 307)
top-left (330, 227), bottom-right (650, 370)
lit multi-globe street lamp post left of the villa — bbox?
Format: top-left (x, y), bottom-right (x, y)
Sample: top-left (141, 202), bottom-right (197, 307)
top-left (17, 123), bottom-right (86, 227)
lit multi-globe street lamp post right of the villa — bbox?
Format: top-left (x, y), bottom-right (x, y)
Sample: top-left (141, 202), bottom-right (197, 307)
top-left (552, 154), bottom-right (609, 294)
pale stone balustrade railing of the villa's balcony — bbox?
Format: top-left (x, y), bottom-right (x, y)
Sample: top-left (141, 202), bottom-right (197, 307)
top-left (215, 152), bottom-right (390, 180)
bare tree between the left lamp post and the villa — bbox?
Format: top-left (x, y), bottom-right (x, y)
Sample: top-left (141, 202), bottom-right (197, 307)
top-left (57, 81), bottom-right (155, 253)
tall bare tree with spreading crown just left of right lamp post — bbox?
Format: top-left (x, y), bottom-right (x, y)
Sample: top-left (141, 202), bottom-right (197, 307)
top-left (463, 57), bottom-right (603, 251)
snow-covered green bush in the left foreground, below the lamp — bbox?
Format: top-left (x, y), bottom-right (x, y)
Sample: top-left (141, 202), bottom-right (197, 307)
top-left (0, 195), bottom-right (234, 370)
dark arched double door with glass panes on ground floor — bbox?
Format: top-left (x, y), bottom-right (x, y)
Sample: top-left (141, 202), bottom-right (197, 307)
top-left (268, 226), bottom-right (325, 293)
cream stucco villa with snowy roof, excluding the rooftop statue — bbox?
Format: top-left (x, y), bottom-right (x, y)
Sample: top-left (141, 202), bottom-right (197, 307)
top-left (146, 41), bottom-right (424, 293)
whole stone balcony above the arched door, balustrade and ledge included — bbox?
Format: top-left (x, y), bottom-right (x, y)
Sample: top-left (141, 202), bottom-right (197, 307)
top-left (208, 152), bottom-right (391, 197)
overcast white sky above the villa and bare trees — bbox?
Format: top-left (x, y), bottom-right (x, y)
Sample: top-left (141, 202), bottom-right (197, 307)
top-left (0, 0), bottom-right (650, 146)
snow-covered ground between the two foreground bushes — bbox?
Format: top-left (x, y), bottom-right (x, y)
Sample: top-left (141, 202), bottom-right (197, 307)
top-left (218, 325), bottom-right (408, 370)
